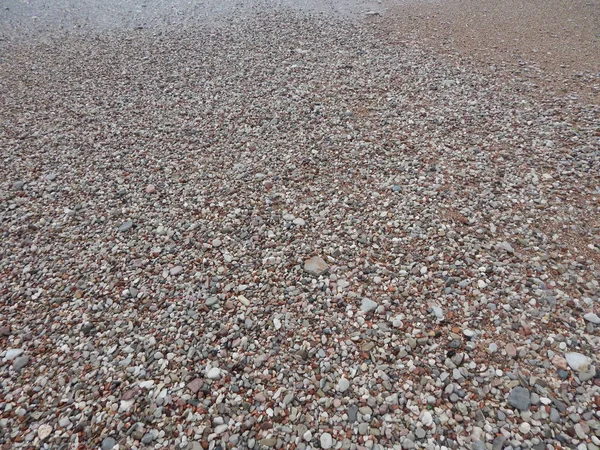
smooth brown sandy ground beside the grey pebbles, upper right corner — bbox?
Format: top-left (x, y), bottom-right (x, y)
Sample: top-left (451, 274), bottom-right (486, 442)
top-left (374, 0), bottom-right (600, 104)
